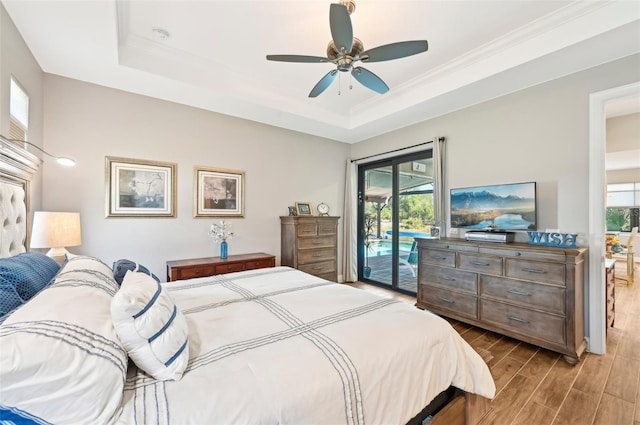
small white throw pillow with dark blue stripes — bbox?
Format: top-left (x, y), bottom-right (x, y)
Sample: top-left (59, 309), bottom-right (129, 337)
top-left (111, 271), bottom-right (189, 381)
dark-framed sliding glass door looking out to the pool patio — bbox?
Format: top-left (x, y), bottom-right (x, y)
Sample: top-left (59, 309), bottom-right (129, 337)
top-left (358, 150), bottom-right (434, 294)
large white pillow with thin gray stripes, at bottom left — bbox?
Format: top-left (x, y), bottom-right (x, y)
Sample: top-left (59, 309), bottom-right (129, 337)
top-left (0, 253), bottom-right (128, 424)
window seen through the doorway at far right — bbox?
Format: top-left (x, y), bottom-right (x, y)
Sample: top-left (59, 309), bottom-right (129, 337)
top-left (606, 182), bottom-right (640, 232)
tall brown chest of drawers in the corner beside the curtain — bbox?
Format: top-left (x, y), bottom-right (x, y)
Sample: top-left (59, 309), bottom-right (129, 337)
top-left (280, 216), bottom-right (340, 282)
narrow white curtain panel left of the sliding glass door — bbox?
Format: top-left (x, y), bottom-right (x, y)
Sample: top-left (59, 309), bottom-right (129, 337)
top-left (342, 160), bottom-right (358, 282)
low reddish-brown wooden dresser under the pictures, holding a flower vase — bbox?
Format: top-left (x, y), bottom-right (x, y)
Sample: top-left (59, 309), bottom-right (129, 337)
top-left (167, 252), bottom-right (276, 282)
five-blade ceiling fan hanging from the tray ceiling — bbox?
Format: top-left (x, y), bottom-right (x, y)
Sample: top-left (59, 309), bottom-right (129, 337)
top-left (267, 0), bottom-right (429, 97)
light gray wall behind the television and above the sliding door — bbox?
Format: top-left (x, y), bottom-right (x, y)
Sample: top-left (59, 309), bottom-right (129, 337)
top-left (351, 55), bottom-right (640, 245)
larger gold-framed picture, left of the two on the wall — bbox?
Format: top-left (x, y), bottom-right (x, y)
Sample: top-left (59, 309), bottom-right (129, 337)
top-left (106, 156), bottom-right (177, 217)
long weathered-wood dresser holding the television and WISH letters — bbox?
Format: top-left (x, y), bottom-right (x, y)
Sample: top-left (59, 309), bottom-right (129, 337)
top-left (416, 239), bottom-right (587, 364)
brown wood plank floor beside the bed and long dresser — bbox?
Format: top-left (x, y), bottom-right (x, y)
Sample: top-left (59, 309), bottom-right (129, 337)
top-left (354, 258), bottom-right (640, 425)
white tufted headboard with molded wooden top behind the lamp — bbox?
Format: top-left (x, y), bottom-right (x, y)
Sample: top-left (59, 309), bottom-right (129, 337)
top-left (0, 136), bottom-right (41, 258)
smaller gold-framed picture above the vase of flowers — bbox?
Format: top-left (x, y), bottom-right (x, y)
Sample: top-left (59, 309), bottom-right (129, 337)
top-left (193, 167), bottom-right (244, 217)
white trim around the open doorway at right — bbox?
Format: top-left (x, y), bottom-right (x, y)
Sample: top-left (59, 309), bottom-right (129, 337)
top-left (585, 82), bottom-right (640, 354)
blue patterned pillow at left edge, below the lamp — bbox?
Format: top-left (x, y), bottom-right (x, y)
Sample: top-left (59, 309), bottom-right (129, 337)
top-left (0, 252), bottom-right (60, 315)
